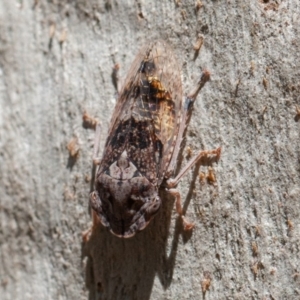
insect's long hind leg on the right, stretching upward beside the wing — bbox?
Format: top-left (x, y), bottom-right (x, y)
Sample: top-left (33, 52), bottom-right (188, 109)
top-left (166, 70), bottom-right (210, 177)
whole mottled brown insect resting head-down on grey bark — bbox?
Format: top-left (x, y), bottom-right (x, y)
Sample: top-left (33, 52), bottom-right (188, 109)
top-left (86, 40), bottom-right (221, 238)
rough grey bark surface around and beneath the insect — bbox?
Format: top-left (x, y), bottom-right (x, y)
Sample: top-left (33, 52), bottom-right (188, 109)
top-left (0, 0), bottom-right (300, 300)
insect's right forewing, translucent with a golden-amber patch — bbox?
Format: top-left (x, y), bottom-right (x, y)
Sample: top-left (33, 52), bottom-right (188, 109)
top-left (141, 41), bottom-right (182, 184)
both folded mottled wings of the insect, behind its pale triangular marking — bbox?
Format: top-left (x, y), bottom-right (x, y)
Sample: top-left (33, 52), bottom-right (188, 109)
top-left (100, 41), bottom-right (182, 184)
